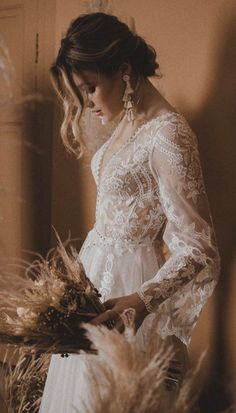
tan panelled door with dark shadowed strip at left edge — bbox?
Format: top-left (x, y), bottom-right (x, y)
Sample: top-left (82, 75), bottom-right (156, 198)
top-left (0, 0), bottom-right (55, 258)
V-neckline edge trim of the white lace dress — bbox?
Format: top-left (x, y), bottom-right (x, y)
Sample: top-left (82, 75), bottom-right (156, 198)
top-left (97, 111), bottom-right (182, 186)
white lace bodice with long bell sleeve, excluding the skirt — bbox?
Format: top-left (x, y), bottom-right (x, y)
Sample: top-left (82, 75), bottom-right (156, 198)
top-left (92, 112), bottom-right (219, 342)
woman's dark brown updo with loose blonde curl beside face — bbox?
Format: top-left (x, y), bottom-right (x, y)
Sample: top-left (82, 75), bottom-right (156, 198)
top-left (51, 13), bottom-right (160, 158)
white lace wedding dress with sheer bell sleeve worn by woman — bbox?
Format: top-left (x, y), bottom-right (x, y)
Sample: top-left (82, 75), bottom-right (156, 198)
top-left (40, 111), bottom-right (219, 413)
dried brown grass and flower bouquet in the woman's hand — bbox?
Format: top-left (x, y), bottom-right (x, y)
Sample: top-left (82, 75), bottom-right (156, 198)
top-left (0, 238), bottom-right (105, 353)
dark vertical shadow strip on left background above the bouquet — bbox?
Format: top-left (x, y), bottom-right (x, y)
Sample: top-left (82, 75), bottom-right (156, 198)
top-left (21, 96), bottom-right (53, 261)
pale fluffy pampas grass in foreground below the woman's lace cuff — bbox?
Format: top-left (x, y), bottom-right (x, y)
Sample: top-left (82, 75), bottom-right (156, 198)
top-left (77, 309), bottom-right (201, 413)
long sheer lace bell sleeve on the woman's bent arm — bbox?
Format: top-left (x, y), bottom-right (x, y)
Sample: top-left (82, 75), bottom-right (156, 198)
top-left (138, 115), bottom-right (220, 342)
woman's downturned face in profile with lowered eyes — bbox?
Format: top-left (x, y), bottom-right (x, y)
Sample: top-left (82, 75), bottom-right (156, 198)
top-left (73, 70), bottom-right (125, 121)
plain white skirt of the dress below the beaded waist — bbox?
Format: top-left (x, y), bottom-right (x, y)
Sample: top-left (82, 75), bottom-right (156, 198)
top-left (40, 230), bottom-right (190, 413)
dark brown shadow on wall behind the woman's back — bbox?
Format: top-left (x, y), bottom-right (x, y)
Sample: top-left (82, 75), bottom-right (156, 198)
top-left (190, 11), bottom-right (236, 413)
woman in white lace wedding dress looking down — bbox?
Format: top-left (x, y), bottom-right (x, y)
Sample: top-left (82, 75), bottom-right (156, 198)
top-left (40, 13), bottom-right (219, 413)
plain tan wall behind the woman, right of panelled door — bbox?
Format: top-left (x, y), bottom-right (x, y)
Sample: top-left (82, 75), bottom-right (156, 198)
top-left (52, 0), bottom-right (236, 413)
